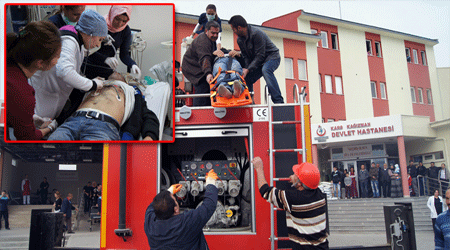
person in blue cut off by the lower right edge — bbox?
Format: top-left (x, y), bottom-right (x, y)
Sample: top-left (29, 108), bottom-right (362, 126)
top-left (434, 189), bottom-right (450, 250)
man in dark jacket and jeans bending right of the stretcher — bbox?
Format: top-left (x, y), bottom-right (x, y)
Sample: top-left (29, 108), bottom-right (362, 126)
top-left (228, 15), bottom-right (284, 103)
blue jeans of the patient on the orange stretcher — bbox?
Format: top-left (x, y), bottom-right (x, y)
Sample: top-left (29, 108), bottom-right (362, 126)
top-left (213, 57), bottom-right (244, 93)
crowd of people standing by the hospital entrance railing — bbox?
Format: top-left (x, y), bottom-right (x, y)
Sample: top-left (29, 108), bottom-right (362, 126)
top-left (331, 161), bottom-right (444, 199)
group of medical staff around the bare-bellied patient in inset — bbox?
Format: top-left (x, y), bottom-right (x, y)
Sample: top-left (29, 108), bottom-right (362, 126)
top-left (6, 5), bottom-right (159, 141)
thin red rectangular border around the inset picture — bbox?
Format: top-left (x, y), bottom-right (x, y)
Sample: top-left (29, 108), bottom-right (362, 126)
top-left (3, 3), bottom-right (175, 143)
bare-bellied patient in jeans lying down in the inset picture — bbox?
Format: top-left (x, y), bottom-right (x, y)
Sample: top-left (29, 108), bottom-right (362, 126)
top-left (48, 80), bottom-right (159, 141)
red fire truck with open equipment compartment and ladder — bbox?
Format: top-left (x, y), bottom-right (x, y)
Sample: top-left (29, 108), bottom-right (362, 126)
top-left (100, 86), bottom-right (312, 249)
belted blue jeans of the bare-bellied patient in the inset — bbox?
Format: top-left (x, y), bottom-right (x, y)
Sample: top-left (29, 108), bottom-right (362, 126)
top-left (48, 116), bottom-right (120, 141)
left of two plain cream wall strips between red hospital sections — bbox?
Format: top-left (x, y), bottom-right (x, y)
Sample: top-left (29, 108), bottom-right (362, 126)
top-left (338, 27), bottom-right (373, 120)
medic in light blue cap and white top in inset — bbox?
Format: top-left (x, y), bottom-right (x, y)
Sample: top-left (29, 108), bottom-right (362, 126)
top-left (30, 10), bottom-right (108, 123)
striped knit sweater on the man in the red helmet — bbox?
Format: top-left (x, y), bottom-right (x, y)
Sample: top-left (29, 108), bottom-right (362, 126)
top-left (259, 184), bottom-right (328, 249)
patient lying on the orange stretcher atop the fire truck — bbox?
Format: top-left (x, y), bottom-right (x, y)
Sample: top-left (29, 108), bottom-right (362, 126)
top-left (213, 54), bottom-right (244, 99)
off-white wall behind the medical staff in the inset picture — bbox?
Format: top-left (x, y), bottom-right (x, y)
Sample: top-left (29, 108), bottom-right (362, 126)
top-left (93, 5), bottom-right (174, 78)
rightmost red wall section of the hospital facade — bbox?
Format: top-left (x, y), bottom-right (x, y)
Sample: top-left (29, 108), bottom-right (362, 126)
top-left (405, 41), bottom-right (435, 122)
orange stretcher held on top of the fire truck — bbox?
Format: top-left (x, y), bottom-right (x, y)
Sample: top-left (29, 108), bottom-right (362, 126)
top-left (209, 68), bottom-right (253, 108)
